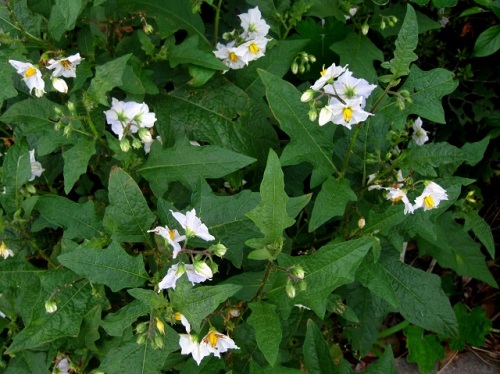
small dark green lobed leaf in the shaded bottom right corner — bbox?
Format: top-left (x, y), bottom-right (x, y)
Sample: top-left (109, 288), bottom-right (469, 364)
top-left (450, 303), bottom-right (492, 351)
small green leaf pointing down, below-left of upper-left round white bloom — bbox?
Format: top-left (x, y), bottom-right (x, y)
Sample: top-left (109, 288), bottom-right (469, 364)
top-left (63, 139), bottom-right (95, 195)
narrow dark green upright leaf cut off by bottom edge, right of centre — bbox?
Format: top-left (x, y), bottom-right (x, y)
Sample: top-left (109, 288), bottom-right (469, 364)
top-left (302, 319), bottom-right (336, 374)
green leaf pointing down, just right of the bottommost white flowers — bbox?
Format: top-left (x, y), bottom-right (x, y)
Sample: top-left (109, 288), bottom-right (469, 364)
top-left (247, 301), bottom-right (282, 366)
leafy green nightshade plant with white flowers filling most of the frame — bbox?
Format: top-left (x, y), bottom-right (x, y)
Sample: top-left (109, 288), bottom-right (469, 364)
top-left (0, 0), bottom-right (497, 374)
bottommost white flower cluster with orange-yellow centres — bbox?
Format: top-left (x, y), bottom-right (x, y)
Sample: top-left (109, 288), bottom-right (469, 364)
top-left (179, 328), bottom-right (240, 365)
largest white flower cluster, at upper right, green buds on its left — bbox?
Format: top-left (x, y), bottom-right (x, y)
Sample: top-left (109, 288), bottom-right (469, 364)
top-left (301, 64), bottom-right (377, 129)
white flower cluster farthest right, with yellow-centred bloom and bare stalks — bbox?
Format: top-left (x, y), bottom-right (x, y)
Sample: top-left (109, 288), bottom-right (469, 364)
top-left (368, 170), bottom-right (448, 214)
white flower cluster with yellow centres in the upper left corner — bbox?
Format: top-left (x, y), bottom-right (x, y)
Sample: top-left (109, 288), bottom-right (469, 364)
top-left (9, 53), bottom-right (83, 97)
